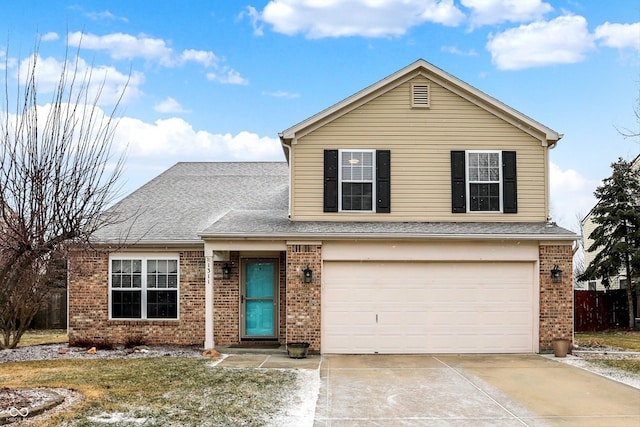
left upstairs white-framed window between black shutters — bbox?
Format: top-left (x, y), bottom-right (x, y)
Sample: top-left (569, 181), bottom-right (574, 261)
top-left (338, 150), bottom-right (376, 212)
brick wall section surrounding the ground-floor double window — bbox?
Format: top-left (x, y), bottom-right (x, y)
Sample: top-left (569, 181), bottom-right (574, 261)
top-left (69, 250), bottom-right (205, 346)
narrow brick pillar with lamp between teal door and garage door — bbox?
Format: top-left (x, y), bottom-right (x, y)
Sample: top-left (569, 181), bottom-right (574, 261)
top-left (287, 245), bottom-right (322, 352)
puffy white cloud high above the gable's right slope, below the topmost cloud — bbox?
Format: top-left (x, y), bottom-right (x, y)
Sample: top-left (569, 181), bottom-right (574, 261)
top-left (487, 15), bottom-right (593, 70)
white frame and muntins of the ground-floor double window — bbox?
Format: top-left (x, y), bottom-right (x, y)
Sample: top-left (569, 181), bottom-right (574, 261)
top-left (107, 253), bottom-right (180, 322)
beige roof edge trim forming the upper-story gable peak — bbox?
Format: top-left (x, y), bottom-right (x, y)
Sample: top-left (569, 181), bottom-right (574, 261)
top-left (279, 59), bottom-right (562, 147)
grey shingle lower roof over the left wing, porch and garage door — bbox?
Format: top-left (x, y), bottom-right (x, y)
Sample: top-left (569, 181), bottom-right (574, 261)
top-left (95, 162), bottom-right (576, 244)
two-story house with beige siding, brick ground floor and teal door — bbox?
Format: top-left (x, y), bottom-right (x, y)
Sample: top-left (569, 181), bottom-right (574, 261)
top-left (69, 60), bottom-right (577, 353)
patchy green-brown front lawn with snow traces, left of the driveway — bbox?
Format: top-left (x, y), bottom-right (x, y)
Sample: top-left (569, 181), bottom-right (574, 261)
top-left (0, 357), bottom-right (296, 426)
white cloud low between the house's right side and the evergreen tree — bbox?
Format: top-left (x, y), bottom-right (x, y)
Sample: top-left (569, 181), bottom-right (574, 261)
top-left (549, 162), bottom-right (600, 231)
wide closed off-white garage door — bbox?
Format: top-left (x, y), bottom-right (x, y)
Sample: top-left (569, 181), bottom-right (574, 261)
top-left (322, 262), bottom-right (534, 354)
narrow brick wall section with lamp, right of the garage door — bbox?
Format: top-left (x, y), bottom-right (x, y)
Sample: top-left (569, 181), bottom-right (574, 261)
top-left (540, 244), bottom-right (573, 352)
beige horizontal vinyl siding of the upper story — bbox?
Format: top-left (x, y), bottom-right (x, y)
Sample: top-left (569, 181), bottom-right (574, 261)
top-left (292, 77), bottom-right (548, 222)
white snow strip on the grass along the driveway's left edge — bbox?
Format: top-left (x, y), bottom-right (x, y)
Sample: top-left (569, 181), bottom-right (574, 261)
top-left (269, 369), bottom-right (320, 427)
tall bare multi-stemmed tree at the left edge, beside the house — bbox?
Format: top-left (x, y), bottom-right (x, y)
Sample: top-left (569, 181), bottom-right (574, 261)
top-left (0, 44), bottom-right (124, 348)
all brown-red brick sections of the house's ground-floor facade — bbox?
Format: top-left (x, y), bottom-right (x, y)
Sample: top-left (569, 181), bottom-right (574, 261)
top-left (69, 244), bottom-right (573, 352)
